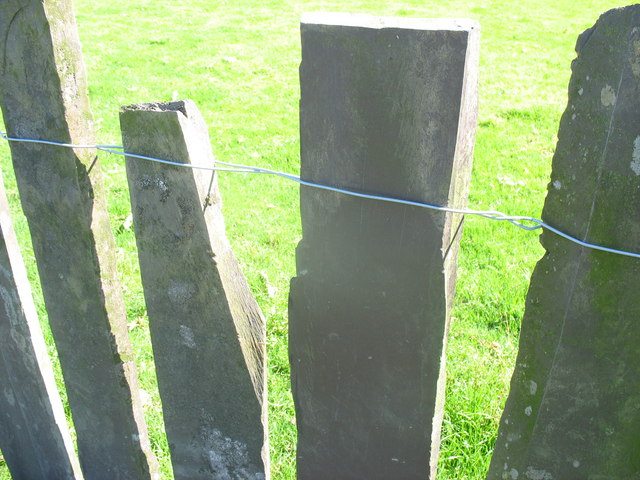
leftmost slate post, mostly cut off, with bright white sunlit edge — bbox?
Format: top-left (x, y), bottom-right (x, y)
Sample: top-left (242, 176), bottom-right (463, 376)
top-left (0, 173), bottom-right (82, 480)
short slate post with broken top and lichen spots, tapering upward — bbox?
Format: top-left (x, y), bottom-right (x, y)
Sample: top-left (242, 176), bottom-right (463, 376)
top-left (120, 100), bottom-right (269, 480)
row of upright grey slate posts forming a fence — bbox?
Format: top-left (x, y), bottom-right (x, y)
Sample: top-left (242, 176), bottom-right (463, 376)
top-left (0, 0), bottom-right (640, 480)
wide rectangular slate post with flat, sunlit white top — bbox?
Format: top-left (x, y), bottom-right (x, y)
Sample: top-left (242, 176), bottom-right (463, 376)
top-left (289, 14), bottom-right (479, 480)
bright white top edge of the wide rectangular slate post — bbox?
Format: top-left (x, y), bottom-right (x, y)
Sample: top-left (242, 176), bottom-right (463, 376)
top-left (300, 12), bottom-right (480, 32)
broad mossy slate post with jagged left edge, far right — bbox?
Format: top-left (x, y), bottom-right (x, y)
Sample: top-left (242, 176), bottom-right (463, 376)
top-left (488, 5), bottom-right (640, 480)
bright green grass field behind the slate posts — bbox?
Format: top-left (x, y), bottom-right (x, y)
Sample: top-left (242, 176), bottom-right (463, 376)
top-left (0, 0), bottom-right (623, 480)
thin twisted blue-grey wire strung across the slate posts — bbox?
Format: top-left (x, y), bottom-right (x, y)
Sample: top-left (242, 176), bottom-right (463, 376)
top-left (0, 130), bottom-right (640, 258)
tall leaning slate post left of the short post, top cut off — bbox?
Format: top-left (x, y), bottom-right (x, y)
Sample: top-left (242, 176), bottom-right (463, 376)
top-left (0, 0), bottom-right (157, 480)
